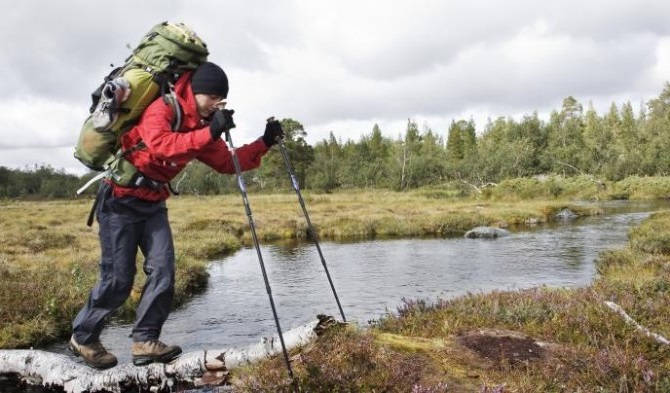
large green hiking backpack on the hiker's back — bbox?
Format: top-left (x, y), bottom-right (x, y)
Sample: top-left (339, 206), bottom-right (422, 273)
top-left (74, 22), bottom-right (209, 190)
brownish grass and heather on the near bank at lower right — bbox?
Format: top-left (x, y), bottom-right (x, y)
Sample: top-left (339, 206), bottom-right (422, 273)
top-left (231, 212), bottom-right (670, 393)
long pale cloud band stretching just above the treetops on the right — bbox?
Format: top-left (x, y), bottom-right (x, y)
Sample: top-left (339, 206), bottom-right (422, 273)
top-left (280, 36), bottom-right (656, 127)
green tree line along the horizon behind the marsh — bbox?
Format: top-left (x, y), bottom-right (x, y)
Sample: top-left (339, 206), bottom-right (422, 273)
top-left (0, 83), bottom-right (670, 198)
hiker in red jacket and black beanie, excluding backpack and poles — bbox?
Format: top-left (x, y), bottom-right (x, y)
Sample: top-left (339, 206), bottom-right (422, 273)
top-left (70, 62), bottom-right (283, 369)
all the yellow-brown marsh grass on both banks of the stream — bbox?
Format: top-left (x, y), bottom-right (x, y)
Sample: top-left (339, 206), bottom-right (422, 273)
top-left (0, 177), bottom-right (670, 393)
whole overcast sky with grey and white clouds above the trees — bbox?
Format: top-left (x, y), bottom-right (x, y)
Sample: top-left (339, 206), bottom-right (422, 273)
top-left (0, 0), bottom-right (670, 173)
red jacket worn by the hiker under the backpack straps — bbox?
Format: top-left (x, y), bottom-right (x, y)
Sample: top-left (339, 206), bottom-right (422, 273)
top-left (114, 73), bottom-right (268, 202)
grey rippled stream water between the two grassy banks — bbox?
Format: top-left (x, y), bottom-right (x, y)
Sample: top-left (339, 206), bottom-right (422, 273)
top-left (48, 202), bottom-right (669, 362)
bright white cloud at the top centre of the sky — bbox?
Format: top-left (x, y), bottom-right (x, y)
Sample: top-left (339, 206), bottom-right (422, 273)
top-left (308, 1), bottom-right (528, 80)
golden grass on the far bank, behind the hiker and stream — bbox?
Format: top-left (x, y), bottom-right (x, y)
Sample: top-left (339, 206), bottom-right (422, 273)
top-left (0, 191), bottom-right (598, 348)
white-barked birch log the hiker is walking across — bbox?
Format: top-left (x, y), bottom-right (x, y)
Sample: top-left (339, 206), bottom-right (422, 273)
top-left (0, 315), bottom-right (338, 393)
